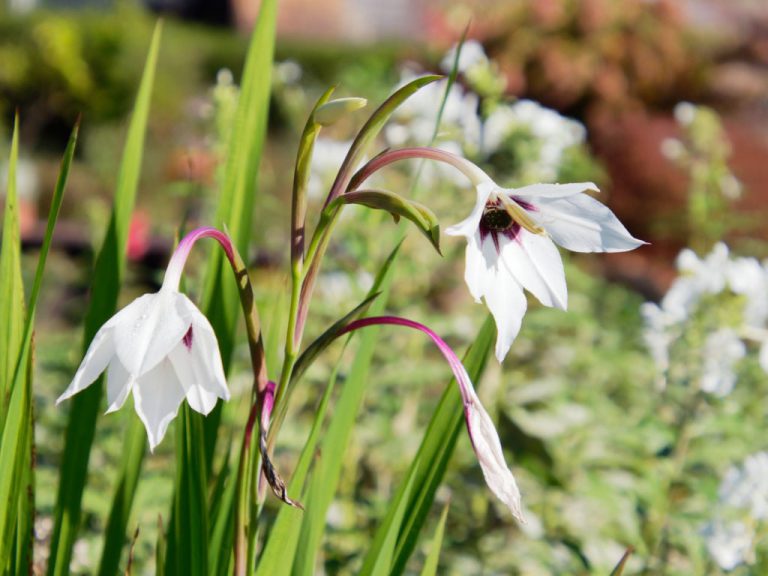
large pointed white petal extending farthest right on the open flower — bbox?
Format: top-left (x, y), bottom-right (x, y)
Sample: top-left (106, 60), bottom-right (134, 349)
top-left (520, 194), bottom-right (645, 252)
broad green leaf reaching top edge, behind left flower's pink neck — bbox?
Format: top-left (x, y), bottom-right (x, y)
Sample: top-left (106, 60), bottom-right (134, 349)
top-left (200, 0), bottom-right (277, 471)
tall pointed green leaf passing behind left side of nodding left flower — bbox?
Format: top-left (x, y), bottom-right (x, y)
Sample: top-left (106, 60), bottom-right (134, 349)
top-left (48, 23), bottom-right (162, 576)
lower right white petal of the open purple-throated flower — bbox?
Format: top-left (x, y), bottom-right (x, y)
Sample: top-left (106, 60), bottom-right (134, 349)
top-left (501, 230), bottom-right (568, 310)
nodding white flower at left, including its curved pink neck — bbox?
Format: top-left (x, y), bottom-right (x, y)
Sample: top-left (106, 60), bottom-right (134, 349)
top-left (56, 229), bottom-right (229, 450)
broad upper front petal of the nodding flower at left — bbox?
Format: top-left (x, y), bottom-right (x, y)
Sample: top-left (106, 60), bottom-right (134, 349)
top-left (115, 290), bottom-right (190, 378)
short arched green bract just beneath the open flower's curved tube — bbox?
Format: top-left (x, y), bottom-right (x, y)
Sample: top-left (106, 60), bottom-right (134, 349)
top-left (328, 190), bottom-right (440, 254)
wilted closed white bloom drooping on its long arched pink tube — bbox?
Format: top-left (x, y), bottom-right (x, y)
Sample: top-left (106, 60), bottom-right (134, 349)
top-left (339, 316), bottom-right (525, 523)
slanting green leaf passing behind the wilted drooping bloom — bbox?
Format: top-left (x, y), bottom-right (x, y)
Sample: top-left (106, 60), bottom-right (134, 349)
top-left (390, 315), bottom-right (496, 574)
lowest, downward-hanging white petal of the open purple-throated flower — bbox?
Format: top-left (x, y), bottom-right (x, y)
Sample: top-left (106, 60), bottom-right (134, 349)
top-left (483, 264), bottom-right (528, 362)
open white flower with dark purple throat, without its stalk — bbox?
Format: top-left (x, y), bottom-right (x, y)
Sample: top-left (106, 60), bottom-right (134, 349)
top-left (446, 179), bottom-right (644, 361)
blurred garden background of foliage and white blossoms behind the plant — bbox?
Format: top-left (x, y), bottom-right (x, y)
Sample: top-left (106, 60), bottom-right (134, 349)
top-left (0, 0), bottom-right (768, 575)
